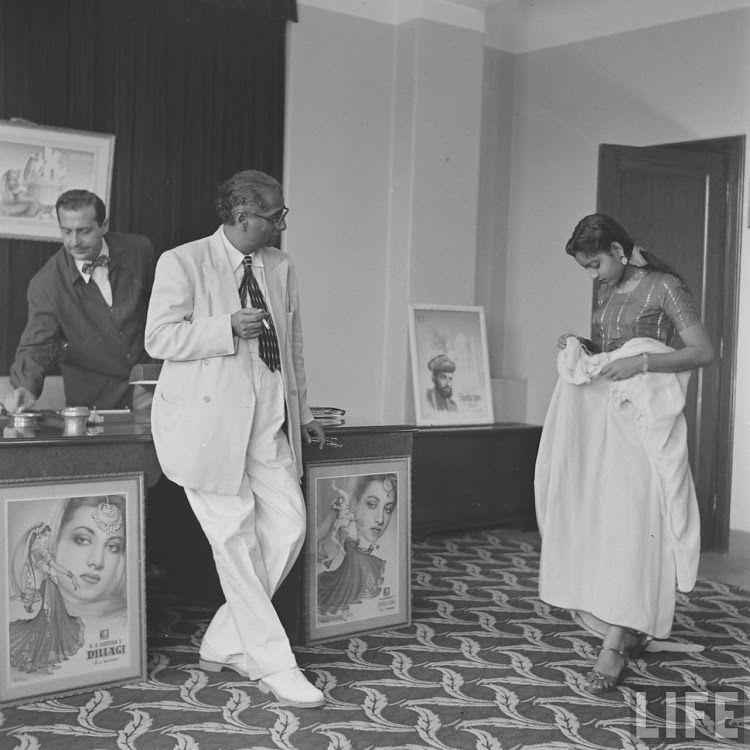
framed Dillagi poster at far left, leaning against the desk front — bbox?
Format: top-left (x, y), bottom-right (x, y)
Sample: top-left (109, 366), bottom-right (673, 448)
top-left (0, 472), bottom-right (146, 704)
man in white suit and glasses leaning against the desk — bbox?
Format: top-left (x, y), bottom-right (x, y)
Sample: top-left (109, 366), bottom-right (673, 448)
top-left (146, 170), bottom-right (325, 708)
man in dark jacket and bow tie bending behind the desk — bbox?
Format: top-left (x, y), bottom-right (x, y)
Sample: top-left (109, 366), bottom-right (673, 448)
top-left (4, 190), bottom-right (154, 413)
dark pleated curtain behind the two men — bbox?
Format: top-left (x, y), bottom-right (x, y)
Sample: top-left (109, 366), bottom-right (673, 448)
top-left (0, 0), bottom-right (296, 374)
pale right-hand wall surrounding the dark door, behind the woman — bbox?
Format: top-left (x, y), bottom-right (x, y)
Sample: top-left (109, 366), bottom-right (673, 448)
top-left (502, 10), bottom-right (750, 529)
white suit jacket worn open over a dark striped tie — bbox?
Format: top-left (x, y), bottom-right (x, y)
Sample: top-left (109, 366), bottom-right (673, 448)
top-left (145, 228), bottom-right (313, 495)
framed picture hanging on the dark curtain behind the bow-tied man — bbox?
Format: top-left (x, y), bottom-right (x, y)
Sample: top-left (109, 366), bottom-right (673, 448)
top-left (0, 120), bottom-right (115, 242)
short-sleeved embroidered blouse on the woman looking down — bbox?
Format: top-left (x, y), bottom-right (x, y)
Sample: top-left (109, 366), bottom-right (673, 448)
top-left (591, 270), bottom-right (700, 352)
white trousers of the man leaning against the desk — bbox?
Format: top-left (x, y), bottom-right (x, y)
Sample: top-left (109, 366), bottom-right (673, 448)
top-left (185, 356), bottom-right (305, 679)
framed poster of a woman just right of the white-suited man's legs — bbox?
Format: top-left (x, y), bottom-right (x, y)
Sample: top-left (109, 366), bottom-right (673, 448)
top-left (304, 456), bottom-right (411, 643)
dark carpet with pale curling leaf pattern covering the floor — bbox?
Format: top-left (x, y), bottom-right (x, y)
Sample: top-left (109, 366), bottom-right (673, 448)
top-left (0, 531), bottom-right (750, 750)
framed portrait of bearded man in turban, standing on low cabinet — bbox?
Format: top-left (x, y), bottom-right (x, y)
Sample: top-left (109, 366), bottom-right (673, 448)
top-left (409, 304), bottom-right (494, 425)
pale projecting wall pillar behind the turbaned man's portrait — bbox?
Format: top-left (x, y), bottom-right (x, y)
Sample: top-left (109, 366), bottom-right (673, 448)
top-left (390, 21), bottom-right (484, 422)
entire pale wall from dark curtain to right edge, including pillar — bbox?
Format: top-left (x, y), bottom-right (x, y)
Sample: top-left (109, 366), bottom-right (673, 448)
top-left (285, 0), bottom-right (750, 530)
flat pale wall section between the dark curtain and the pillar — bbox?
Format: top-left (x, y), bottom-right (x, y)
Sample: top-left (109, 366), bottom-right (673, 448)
top-left (284, 6), bottom-right (395, 424)
